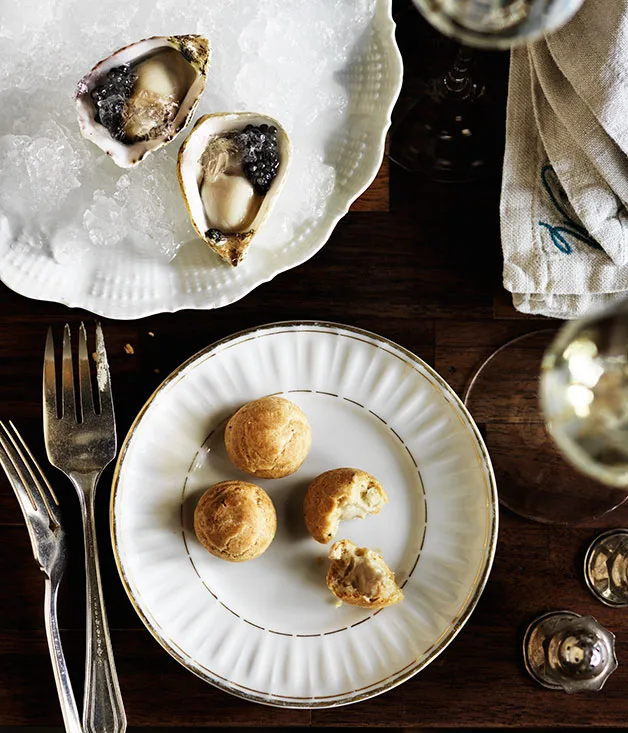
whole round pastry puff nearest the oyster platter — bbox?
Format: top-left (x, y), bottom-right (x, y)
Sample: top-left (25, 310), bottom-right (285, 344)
top-left (225, 396), bottom-right (312, 478)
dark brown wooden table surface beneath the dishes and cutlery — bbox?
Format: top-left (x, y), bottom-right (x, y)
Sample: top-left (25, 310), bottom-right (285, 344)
top-left (0, 4), bottom-right (628, 728)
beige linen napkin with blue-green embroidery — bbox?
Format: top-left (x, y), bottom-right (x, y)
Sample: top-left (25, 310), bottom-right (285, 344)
top-left (500, 0), bottom-right (628, 318)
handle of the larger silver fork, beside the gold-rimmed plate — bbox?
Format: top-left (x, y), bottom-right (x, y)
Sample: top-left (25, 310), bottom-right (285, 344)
top-left (72, 474), bottom-right (126, 733)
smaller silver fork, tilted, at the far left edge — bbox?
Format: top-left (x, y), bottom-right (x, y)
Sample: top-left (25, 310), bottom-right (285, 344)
top-left (0, 422), bottom-right (82, 733)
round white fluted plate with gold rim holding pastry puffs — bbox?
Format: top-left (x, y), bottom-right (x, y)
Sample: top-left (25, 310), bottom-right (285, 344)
top-left (111, 323), bottom-right (497, 708)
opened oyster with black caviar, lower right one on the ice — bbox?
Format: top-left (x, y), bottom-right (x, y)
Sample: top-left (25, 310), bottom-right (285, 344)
top-left (177, 112), bottom-right (291, 267)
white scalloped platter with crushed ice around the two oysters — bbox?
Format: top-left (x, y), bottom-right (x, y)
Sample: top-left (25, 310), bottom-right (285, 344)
top-left (0, 0), bottom-right (403, 319)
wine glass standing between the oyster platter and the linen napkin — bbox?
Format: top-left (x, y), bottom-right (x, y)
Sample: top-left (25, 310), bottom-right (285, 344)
top-left (389, 0), bottom-right (583, 183)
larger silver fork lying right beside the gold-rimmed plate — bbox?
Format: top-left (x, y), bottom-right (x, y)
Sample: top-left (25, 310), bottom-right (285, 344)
top-left (44, 323), bottom-right (126, 733)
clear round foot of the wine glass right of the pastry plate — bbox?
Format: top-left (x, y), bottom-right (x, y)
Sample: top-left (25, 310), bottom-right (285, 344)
top-left (464, 329), bottom-right (628, 524)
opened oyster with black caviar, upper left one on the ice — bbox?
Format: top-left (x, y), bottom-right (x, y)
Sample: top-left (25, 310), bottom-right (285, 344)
top-left (76, 35), bottom-right (209, 168)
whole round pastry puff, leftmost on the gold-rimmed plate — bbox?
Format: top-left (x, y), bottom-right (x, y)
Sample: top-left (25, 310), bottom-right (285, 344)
top-left (194, 481), bottom-right (277, 562)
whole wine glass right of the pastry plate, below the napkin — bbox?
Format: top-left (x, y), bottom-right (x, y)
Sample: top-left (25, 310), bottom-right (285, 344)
top-left (464, 300), bottom-right (628, 524)
